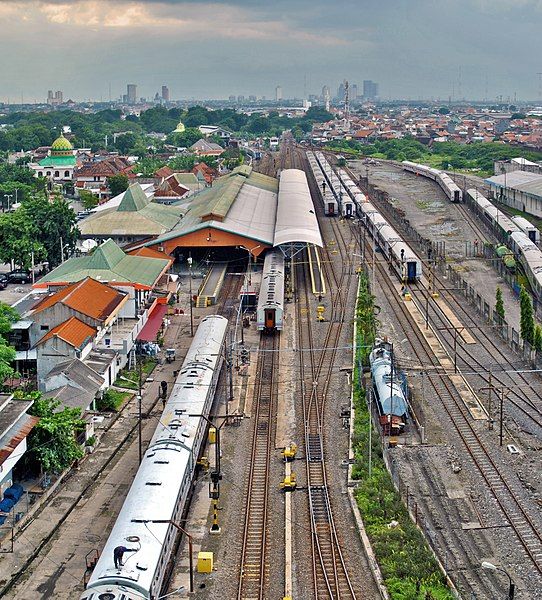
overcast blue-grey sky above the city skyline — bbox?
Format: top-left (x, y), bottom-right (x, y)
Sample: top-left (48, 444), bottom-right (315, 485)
top-left (0, 0), bottom-right (542, 102)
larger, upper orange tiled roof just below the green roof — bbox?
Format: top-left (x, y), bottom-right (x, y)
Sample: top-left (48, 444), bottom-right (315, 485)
top-left (33, 277), bottom-right (126, 321)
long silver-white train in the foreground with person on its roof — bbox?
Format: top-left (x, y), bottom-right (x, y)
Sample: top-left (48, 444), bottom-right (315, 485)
top-left (81, 315), bottom-right (228, 600)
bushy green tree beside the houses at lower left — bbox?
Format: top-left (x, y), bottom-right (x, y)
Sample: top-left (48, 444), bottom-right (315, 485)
top-left (28, 392), bottom-right (85, 474)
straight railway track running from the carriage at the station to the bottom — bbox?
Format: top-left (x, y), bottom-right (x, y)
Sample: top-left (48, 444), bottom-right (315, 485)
top-left (237, 334), bottom-right (279, 600)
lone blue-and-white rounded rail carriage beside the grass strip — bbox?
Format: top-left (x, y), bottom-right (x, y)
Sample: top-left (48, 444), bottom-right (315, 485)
top-left (369, 340), bottom-right (408, 435)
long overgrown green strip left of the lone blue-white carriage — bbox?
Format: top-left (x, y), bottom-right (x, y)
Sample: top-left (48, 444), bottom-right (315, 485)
top-left (352, 273), bottom-right (454, 600)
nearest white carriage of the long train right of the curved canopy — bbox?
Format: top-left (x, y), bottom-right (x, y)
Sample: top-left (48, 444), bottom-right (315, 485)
top-left (360, 202), bottom-right (422, 283)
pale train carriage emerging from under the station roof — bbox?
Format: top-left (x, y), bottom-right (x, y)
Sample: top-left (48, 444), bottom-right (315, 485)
top-left (256, 250), bottom-right (284, 332)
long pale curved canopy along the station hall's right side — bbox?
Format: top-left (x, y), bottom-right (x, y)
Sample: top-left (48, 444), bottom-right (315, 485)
top-left (273, 169), bottom-right (323, 248)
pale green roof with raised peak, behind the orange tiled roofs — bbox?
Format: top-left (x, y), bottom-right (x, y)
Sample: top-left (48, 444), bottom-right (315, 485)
top-left (38, 240), bottom-right (169, 287)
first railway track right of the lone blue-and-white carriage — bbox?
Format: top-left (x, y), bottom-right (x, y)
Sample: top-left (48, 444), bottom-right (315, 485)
top-left (360, 218), bottom-right (542, 588)
